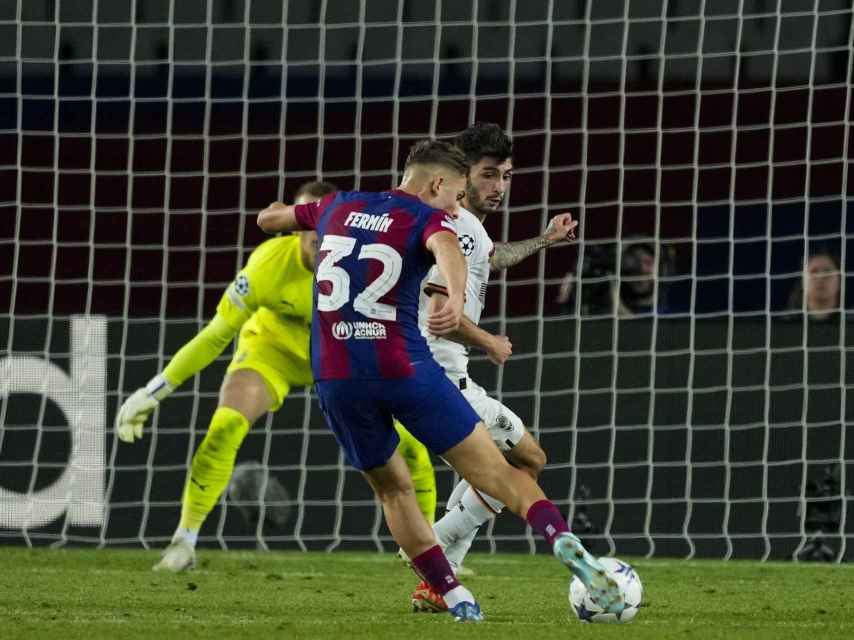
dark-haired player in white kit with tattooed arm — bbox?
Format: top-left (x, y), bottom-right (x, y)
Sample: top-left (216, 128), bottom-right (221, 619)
top-left (412, 123), bottom-right (578, 611)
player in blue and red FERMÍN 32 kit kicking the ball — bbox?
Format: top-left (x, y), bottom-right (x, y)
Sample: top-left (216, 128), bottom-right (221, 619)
top-left (258, 140), bottom-right (623, 621)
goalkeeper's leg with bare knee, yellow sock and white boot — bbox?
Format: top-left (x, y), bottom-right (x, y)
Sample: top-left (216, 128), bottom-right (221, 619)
top-left (154, 368), bottom-right (274, 571)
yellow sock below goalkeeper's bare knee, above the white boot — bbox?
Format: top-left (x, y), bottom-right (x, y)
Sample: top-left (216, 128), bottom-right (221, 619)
top-left (178, 407), bottom-right (249, 530)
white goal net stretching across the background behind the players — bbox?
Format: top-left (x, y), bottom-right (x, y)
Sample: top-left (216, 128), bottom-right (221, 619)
top-left (0, 0), bottom-right (854, 561)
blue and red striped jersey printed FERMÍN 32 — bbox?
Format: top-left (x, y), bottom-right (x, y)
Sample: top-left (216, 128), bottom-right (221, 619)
top-left (296, 189), bottom-right (456, 380)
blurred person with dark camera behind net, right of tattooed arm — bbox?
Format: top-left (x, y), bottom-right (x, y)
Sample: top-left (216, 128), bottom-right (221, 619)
top-left (556, 242), bottom-right (673, 318)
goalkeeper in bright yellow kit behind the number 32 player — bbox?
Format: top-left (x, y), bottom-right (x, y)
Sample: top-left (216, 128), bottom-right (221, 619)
top-left (116, 182), bottom-right (436, 571)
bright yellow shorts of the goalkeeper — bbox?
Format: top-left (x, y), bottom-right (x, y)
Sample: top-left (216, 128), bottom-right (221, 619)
top-left (227, 318), bottom-right (312, 411)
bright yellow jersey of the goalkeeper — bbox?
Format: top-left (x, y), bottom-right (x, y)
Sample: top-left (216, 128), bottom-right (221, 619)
top-left (217, 235), bottom-right (314, 379)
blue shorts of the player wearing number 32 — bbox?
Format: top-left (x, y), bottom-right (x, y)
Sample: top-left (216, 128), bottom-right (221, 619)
top-left (315, 362), bottom-right (480, 471)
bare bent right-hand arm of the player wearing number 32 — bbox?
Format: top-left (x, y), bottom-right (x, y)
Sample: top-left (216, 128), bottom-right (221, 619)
top-left (426, 231), bottom-right (468, 336)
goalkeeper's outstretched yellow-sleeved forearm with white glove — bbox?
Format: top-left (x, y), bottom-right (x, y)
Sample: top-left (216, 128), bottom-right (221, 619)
top-left (116, 314), bottom-right (237, 442)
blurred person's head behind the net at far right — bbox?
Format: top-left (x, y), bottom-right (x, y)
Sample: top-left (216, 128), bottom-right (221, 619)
top-left (786, 249), bottom-right (842, 322)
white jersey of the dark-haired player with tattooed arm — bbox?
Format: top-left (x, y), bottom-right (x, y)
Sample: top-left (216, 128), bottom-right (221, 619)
top-left (418, 207), bottom-right (493, 377)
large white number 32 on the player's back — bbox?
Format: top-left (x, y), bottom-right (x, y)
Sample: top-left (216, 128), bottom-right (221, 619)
top-left (315, 235), bottom-right (403, 321)
